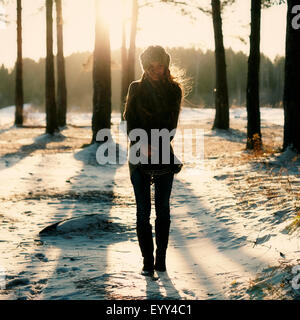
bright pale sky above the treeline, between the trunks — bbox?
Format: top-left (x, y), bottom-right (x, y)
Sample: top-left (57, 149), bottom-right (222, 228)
top-left (0, 0), bottom-right (286, 68)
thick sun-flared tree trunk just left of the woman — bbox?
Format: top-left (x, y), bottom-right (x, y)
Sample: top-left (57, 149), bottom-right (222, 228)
top-left (92, 0), bottom-right (111, 143)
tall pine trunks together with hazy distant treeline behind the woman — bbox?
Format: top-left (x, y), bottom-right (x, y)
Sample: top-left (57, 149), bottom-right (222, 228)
top-left (0, 0), bottom-right (299, 150)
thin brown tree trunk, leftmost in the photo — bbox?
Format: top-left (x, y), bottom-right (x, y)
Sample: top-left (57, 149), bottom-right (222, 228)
top-left (15, 0), bottom-right (24, 127)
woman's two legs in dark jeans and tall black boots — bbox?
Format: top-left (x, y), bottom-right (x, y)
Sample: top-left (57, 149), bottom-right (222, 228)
top-left (130, 168), bottom-right (174, 269)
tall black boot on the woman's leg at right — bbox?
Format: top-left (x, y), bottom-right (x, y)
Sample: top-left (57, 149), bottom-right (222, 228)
top-left (154, 219), bottom-right (171, 271)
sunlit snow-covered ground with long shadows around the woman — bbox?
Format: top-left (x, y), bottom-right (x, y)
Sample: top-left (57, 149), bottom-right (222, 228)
top-left (0, 106), bottom-right (300, 299)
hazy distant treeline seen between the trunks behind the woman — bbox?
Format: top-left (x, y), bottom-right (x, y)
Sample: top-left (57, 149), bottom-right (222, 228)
top-left (0, 48), bottom-right (284, 112)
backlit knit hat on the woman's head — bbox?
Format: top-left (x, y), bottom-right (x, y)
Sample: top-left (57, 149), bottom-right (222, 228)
top-left (140, 46), bottom-right (170, 70)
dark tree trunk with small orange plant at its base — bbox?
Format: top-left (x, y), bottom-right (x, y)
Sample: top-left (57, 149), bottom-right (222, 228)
top-left (246, 0), bottom-right (262, 150)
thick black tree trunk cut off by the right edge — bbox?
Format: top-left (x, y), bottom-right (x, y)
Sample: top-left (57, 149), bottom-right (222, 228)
top-left (283, 0), bottom-right (300, 153)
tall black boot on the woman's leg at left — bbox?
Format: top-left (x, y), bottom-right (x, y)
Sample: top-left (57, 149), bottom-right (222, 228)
top-left (136, 223), bottom-right (154, 276)
